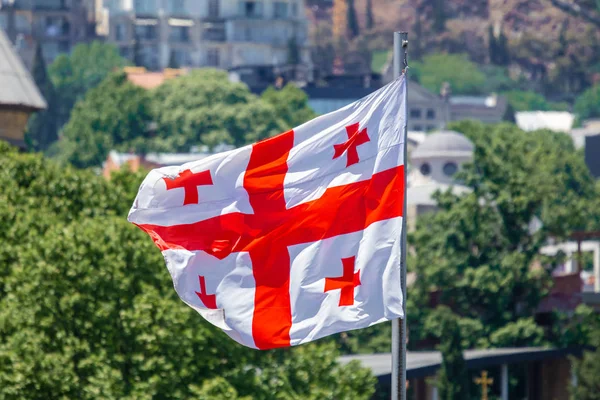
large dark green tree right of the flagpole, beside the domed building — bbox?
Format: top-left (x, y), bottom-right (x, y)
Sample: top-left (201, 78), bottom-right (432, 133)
top-left (408, 122), bottom-right (597, 347)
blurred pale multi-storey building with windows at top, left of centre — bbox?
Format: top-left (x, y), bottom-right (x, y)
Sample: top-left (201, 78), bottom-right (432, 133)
top-left (95, 0), bottom-right (310, 70)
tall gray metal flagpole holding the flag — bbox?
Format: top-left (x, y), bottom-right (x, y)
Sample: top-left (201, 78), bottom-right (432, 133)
top-left (392, 32), bottom-right (408, 400)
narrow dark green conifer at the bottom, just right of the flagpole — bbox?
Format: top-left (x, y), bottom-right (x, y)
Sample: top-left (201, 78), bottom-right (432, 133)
top-left (434, 307), bottom-right (469, 400)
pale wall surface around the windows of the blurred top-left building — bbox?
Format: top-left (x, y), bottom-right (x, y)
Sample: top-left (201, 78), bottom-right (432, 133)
top-left (96, 0), bottom-right (311, 68)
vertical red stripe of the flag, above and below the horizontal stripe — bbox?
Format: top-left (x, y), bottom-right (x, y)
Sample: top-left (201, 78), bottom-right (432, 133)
top-left (244, 131), bottom-right (294, 349)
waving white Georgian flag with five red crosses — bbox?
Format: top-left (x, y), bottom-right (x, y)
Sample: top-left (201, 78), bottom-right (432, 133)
top-left (128, 77), bottom-right (406, 349)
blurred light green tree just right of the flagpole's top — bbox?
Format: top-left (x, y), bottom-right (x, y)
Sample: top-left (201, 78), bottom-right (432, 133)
top-left (411, 53), bottom-right (485, 94)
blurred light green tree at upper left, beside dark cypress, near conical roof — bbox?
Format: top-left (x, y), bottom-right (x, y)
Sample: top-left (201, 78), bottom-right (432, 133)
top-left (48, 41), bottom-right (128, 126)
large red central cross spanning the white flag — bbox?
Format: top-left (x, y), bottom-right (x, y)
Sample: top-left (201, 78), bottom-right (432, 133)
top-left (140, 126), bottom-right (404, 349)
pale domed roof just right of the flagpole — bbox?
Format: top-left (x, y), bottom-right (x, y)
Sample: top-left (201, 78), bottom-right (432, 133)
top-left (411, 131), bottom-right (475, 159)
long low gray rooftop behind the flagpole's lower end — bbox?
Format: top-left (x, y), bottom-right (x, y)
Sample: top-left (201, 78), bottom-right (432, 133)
top-left (338, 347), bottom-right (579, 378)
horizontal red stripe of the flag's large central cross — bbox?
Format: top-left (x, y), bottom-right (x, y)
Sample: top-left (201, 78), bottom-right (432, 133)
top-left (139, 166), bottom-right (404, 258)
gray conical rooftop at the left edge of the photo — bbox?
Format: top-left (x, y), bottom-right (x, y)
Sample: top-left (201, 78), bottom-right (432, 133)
top-left (0, 28), bottom-right (47, 110)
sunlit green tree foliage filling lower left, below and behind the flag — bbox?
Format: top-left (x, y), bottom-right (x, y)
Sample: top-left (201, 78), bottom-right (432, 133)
top-left (0, 142), bottom-right (374, 400)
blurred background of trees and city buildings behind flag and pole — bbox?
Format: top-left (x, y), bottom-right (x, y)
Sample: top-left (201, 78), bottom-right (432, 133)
top-left (0, 0), bottom-right (600, 400)
